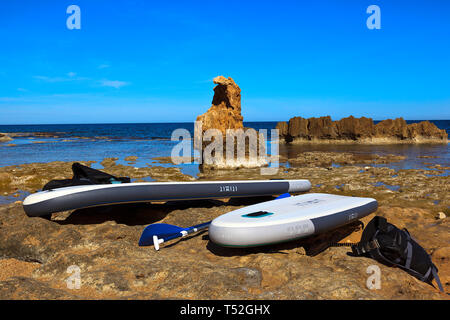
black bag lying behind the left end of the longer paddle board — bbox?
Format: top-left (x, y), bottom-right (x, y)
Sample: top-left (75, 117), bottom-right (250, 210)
top-left (42, 162), bottom-right (130, 190)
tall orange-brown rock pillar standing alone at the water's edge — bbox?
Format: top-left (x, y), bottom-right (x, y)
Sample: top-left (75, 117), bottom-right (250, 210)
top-left (194, 76), bottom-right (266, 169)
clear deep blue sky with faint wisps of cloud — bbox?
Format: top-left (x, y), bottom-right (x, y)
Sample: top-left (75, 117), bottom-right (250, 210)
top-left (0, 0), bottom-right (450, 124)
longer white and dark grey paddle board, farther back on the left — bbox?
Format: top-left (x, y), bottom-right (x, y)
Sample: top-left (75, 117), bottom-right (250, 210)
top-left (23, 180), bottom-right (311, 216)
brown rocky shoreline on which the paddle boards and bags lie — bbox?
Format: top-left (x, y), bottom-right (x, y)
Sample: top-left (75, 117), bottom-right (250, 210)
top-left (0, 152), bottom-right (450, 299)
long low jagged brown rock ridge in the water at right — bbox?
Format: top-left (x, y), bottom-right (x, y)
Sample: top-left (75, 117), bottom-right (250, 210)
top-left (277, 116), bottom-right (448, 143)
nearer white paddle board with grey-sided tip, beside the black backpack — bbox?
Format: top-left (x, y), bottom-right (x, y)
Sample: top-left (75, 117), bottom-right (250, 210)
top-left (209, 193), bottom-right (378, 247)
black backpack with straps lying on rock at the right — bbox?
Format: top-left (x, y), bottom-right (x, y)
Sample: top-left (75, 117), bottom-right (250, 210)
top-left (352, 216), bottom-right (444, 292)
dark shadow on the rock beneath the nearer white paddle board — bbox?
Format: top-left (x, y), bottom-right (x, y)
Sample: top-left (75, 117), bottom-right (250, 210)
top-left (203, 221), bottom-right (362, 257)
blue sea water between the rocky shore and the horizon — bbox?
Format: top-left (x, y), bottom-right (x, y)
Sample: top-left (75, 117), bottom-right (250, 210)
top-left (0, 120), bottom-right (450, 177)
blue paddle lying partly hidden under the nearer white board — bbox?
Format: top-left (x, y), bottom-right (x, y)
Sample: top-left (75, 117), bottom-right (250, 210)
top-left (139, 193), bottom-right (291, 250)
